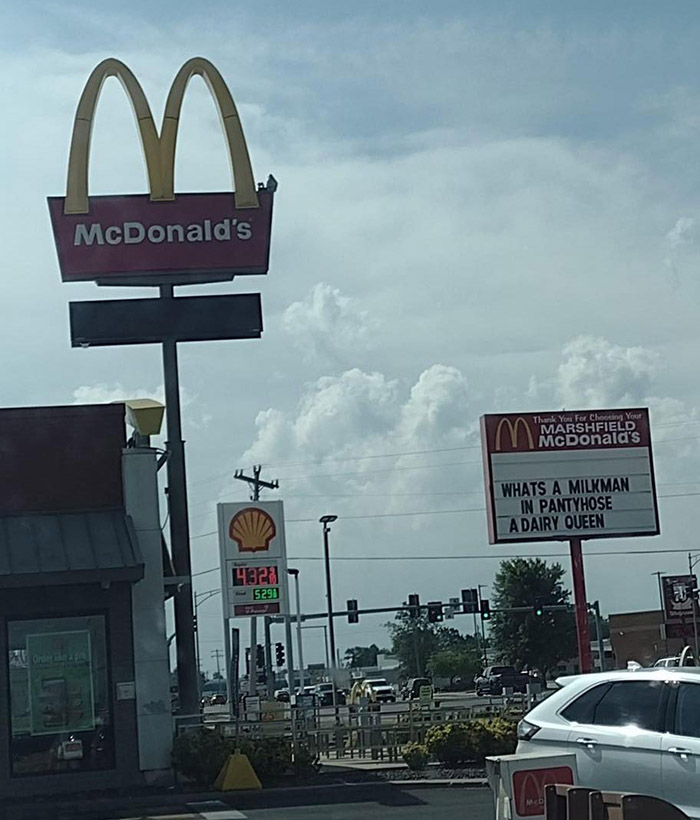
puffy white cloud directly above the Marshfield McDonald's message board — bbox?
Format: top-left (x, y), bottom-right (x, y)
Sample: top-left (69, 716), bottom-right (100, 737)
top-left (556, 336), bottom-right (659, 409)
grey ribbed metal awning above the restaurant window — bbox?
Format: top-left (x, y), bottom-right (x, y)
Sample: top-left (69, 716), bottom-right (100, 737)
top-left (0, 510), bottom-right (144, 588)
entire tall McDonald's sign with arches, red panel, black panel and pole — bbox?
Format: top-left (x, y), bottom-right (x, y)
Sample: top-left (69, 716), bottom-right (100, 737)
top-left (48, 57), bottom-right (277, 714)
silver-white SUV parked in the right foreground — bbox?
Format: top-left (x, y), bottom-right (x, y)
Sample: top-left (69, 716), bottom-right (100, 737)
top-left (517, 667), bottom-right (700, 820)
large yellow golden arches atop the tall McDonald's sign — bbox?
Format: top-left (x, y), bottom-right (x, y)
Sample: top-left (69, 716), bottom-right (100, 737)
top-left (64, 57), bottom-right (259, 214)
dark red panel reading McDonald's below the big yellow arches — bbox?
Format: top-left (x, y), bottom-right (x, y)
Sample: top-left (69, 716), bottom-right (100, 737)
top-left (48, 189), bottom-right (273, 284)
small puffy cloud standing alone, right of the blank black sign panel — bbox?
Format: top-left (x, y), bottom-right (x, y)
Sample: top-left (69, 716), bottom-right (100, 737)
top-left (282, 282), bottom-right (370, 364)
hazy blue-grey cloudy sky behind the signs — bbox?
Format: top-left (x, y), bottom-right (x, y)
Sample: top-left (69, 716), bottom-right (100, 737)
top-left (0, 0), bottom-right (700, 668)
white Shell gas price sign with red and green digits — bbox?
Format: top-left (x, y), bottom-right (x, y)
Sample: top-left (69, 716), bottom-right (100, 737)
top-left (217, 501), bottom-right (289, 618)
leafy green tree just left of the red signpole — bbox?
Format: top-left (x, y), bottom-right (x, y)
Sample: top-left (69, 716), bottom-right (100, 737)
top-left (491, 558), bottom-right (576, 677)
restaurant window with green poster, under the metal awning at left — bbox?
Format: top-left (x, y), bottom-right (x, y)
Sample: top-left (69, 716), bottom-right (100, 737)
top-left (8, 615), bottom-right (114, 775)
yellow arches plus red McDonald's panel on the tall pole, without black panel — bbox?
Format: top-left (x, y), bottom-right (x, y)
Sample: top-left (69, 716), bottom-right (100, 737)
top-left (48, 57), bottom-right (277, 285)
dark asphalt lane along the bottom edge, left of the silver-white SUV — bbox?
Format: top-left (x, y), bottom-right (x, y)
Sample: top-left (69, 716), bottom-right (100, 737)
top-left (105, 784), bottom-right (494, 820)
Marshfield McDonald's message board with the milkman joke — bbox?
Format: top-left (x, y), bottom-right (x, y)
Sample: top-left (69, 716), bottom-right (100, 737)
top-left (481, 408), bottom-right (660, 544)
